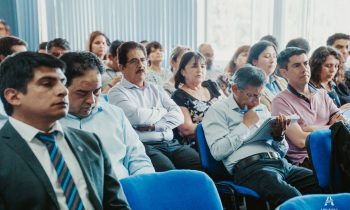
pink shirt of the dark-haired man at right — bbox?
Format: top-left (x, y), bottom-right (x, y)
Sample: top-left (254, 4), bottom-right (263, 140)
top-left (272, 86), bottom-right (339, 165)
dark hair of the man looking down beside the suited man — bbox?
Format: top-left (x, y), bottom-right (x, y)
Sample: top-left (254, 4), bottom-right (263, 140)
top-left (60, 51), bottom-right (104, 87)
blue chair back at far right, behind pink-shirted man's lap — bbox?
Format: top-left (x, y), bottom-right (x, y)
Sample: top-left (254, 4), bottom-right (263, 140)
top-left (306, 129), bottom-right (332, 189)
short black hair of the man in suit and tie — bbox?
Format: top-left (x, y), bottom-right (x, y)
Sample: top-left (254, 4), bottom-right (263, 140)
top-left (0, 52), bottom-right (65, 116)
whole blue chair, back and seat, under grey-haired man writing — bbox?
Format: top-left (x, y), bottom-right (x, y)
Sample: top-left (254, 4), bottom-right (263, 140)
top-left (196, 123), bottom-right (266, 209)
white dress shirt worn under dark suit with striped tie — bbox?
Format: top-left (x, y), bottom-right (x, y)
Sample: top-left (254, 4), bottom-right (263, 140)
top-left (9, 117), bottom-right (94, 210)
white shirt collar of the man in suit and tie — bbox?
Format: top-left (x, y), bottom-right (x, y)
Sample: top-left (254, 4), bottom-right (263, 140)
top-left (9, 117), bottom-right (64, 143)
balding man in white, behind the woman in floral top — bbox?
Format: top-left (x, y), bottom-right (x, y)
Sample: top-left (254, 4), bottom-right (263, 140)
top-left (198, 43), bottom-right (223, 81)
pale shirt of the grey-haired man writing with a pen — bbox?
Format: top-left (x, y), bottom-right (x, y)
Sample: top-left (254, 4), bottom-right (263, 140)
top-left (202, 95), bottom-right (288, 173)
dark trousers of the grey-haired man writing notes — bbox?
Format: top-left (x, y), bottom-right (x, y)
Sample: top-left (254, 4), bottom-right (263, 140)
top-left (233, 158), bottom-right (321, 209)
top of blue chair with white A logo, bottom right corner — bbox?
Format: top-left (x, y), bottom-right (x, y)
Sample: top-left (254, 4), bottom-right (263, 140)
top-left (277, 193), bottom-right (350, 210)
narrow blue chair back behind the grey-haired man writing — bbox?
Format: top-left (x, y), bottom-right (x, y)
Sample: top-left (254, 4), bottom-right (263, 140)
top-left (196, 123), bottom-right (230, 179)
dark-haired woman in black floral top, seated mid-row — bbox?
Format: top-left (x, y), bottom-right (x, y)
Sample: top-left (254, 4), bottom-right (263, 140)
top-left (172, 51), bottom-right (222, 146)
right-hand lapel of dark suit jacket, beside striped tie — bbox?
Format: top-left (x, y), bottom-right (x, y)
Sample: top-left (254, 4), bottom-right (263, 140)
top-left (63, 127), bottom-right (103, 209)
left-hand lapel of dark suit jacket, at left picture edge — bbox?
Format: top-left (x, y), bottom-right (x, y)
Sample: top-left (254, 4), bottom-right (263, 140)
top-left (1, 121), bottom-right (59, 209)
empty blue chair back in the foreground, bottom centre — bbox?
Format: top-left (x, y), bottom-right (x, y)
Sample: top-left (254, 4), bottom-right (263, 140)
top-left (120, 170), bottom-right (223, 210)
